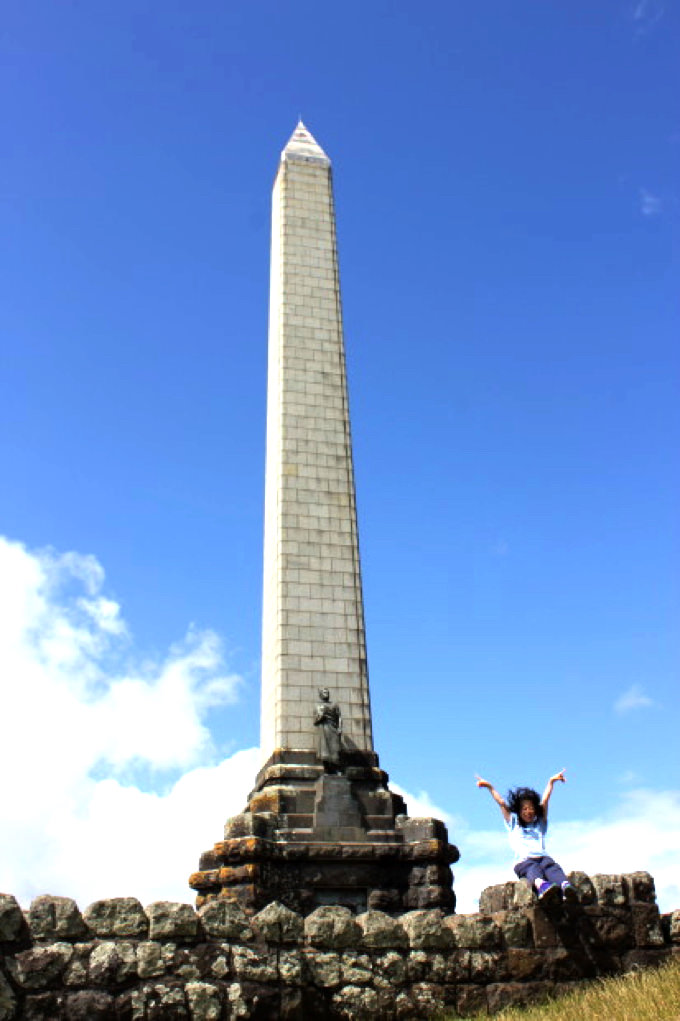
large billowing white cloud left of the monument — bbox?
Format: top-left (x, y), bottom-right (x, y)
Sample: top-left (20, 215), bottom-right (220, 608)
top-left (0, 537), bottom-right (253, 905)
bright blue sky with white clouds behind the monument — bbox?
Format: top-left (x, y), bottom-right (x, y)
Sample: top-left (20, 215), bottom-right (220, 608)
top-left (0, 0), bottom-right (680, 910)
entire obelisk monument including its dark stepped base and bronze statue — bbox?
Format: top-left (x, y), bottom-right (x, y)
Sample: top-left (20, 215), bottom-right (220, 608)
top-left (189, 123), bottom-right (458, 915)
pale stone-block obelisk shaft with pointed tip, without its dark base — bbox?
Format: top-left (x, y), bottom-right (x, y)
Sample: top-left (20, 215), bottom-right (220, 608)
top-left (260, 121), bottom-right (373, 761)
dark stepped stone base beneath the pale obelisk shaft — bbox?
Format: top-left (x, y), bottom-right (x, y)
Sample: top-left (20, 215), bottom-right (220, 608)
top-left (189, 749), bottom-right (458, 915)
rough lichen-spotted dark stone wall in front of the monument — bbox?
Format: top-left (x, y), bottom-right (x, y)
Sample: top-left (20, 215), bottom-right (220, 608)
top-left (0, 872), bottom-right (680, 1021)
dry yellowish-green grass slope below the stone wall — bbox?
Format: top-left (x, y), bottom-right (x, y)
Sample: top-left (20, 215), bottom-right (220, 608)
top-left (455, 960), bottom-right (680, 1021)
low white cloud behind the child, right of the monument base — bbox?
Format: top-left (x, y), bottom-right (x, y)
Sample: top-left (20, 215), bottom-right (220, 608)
top-left (450, 788), bottom-right (680, 912)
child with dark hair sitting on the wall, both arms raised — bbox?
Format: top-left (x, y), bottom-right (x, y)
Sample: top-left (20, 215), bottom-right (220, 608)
top-left (477, 769), bottom-right (578, 904)
